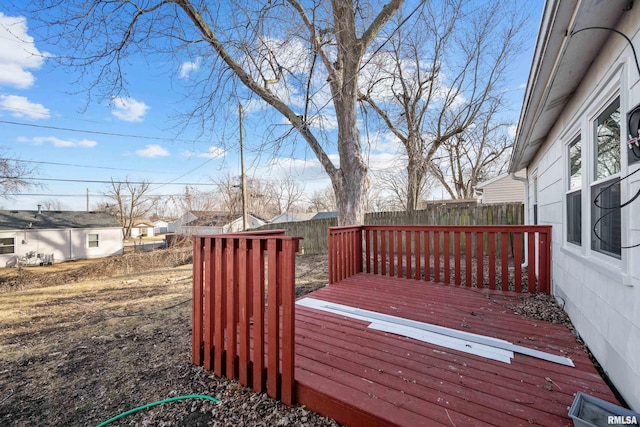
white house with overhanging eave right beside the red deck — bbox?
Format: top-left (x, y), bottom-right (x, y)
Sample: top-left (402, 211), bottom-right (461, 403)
top-left (509, 0), bottom-right (640, 411)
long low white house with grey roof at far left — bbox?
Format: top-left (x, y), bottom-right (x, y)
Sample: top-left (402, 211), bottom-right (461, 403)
top-left (0, 210), bottom-right (123, 267)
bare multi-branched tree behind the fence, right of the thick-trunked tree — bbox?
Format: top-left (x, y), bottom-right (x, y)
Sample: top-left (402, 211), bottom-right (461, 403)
top-left (360, 0), bottom-right (521, 210)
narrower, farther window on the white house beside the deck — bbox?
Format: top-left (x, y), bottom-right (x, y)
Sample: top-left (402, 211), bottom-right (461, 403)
top-left (567, 136), bottom-right (582, 245)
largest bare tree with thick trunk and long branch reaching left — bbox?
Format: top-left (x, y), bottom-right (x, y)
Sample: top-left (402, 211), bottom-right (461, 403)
top-left (28, 0), bottom-right (403, 224)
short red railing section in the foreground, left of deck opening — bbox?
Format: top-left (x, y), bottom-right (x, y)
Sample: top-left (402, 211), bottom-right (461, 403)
top-left (192, 230), bottom-right (300, 405)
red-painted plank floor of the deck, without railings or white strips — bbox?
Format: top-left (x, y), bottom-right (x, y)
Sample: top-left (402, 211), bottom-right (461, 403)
top-left (295, 273), bottom-right (616, 426)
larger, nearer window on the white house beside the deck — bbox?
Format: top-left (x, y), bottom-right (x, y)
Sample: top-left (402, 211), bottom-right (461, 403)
top-left (591, 98), bottom-right (622, 258)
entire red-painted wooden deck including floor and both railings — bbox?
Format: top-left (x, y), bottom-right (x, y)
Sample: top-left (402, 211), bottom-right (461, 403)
top-left (192, 231), bottom-right (615, 427)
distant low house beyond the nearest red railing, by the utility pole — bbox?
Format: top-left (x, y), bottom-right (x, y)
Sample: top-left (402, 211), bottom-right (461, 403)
top-left (175, 211), bottom-right (267, 235)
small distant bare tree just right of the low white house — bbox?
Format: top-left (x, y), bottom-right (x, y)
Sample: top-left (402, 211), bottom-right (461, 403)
top-left (105, 179), bottom-right (154, 239)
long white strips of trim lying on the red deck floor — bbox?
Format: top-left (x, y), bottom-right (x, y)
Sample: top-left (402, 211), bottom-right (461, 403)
top-left (296, 298), bottom-right (574, 367)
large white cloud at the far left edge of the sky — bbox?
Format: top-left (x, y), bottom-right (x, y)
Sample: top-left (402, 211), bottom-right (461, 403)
top-left (0, 12), bottom-right (45, 89)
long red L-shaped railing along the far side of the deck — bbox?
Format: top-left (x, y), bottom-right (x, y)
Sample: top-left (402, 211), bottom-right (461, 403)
top-left (329, 225), bottom-right (551, 293)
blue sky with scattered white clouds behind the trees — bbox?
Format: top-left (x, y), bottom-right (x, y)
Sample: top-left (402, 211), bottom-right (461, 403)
top-left (0, 0), bottom-right (543, 210)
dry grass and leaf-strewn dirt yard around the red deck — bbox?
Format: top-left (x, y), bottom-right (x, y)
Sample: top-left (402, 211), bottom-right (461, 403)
top-left (0, 249), bottom-right (568, 427)
